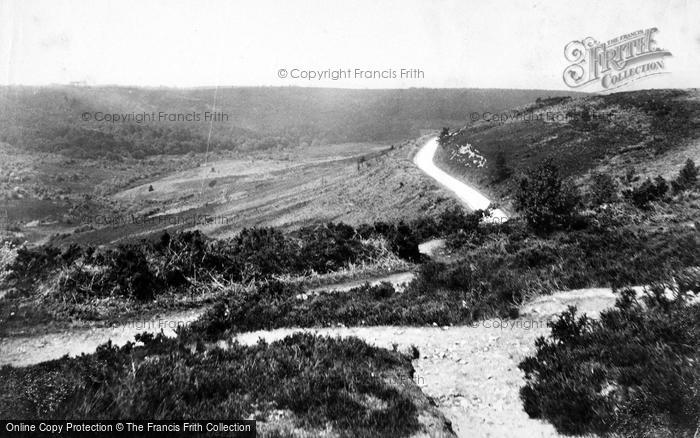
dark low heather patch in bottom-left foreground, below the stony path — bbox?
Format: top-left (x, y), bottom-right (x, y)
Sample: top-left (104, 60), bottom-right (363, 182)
top-left (0, 334), bottom-right (419, 437)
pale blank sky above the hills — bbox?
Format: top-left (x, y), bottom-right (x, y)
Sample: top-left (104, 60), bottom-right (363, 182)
top-left (0, 0), bottom-right (700, 91)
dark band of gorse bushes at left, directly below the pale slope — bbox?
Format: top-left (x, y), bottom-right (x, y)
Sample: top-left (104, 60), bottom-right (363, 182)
top-left (5, 223), bottom-right (419, 302)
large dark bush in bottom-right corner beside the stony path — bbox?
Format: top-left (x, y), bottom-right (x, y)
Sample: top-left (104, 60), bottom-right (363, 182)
top-left (520, 289), bottom-right (700, 438)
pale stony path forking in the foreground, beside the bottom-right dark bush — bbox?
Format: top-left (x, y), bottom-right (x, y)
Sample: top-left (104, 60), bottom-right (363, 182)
top-left (235, 288), bottom-right (644, 438)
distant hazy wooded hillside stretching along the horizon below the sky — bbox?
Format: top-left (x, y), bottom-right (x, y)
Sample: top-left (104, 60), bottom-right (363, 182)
top-left (0, 86), bottom-right (576, 159)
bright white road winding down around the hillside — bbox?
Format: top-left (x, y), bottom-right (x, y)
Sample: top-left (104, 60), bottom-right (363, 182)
top-left (413, 137), bottom-right (508, 222)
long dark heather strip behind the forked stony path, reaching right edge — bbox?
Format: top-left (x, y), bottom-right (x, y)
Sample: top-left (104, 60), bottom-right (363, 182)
top-left (182, 224), bottom-right (700, 340)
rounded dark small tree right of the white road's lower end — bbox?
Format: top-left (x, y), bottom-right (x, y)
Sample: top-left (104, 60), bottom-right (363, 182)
top-left (515, 160), bottom-right (580, 231)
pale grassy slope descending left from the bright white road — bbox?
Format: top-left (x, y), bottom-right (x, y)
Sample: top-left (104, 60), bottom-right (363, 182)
top-left (64, 140), bottom-right (457, 243)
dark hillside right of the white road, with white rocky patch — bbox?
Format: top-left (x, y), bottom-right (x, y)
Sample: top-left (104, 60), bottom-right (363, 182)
top-left (436, 90), bottom-right (700, 209)
